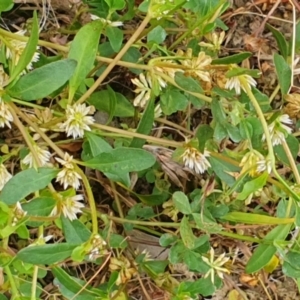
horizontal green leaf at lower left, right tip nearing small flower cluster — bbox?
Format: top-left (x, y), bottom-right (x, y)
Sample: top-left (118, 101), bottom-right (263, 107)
top-left (17, 243), bottom-right (76, 265)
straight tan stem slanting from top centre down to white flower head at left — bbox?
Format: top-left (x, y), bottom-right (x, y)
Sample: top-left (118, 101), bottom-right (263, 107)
top-left (77, 15), bottom-right (151, 104)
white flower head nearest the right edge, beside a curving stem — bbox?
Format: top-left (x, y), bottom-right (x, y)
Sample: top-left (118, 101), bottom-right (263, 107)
top-left (262, 114), bottom-right (293, 146)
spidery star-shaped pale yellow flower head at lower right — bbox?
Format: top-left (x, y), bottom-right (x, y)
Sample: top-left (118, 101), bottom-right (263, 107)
top-left (202, 247), bottom-right (230, 283)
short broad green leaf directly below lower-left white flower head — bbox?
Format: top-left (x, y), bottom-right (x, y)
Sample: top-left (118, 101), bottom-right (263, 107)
top-left (61, 217), bottom-right (91, 245)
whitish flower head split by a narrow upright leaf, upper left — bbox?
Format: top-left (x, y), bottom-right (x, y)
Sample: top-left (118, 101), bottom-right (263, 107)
top-left (6, 30), bottom-right (40, 71)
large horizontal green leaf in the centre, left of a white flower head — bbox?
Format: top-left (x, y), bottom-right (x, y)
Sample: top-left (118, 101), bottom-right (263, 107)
top-left (83, 148), bottom-right (155, 174)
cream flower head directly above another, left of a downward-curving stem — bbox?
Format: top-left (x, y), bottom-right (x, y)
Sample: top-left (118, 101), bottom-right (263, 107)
top-left (55, 153), bottom-right (81, 190)
